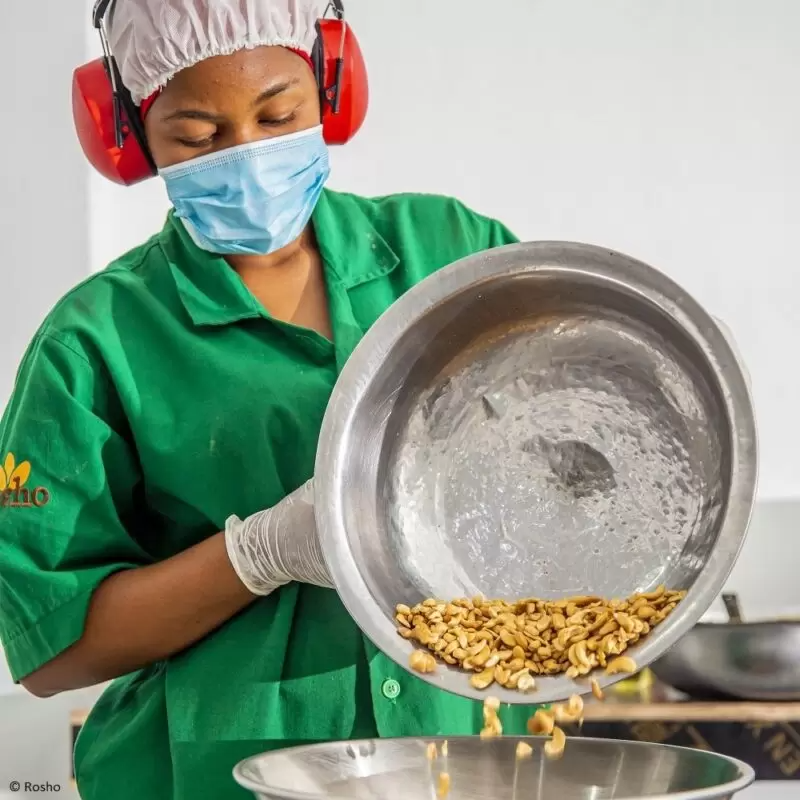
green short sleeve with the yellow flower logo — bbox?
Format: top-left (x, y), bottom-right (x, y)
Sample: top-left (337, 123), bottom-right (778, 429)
top-left (0, 334), bottom-right (148, 680)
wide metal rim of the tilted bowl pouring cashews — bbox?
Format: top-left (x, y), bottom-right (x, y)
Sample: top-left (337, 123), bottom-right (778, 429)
top-left (314, 241), bottom-right (758, 705)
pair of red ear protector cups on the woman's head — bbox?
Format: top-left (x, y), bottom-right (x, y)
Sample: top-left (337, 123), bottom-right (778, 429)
top-left (72, 0), bottom-right (369, 186)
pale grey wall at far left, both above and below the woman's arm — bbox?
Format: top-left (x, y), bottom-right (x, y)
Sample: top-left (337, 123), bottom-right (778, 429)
top-left (0, 0), bottom-right (97, 798)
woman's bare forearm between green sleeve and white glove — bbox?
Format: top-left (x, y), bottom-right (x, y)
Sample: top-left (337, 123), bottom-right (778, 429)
top-left (21, 533), bottom-right (256, 697)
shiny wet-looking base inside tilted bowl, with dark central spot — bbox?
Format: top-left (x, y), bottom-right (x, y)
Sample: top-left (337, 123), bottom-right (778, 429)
top-left (388, 308), bottom-right (724, 598)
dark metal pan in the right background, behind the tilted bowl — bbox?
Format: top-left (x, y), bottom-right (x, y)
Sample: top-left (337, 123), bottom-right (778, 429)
top-left (652, 620), bottom-right (800, 701)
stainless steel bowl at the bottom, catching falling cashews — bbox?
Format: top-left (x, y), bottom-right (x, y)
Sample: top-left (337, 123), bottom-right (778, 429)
top-left (234, 736), bottom-right (755, 800)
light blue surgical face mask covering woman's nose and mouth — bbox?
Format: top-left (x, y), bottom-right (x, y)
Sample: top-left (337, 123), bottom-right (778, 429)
top-left (159, 125), bottom-right (330, 255)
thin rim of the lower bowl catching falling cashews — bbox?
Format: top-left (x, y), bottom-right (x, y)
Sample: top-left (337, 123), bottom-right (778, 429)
top-left (233, 736), bottom-right (756, 800)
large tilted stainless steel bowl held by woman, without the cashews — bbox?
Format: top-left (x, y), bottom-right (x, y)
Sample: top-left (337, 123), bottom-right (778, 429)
top-left (315, 242), bottom-right (756, 703)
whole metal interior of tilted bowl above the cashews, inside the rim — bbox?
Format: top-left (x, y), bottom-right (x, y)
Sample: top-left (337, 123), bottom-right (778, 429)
top-left (343, 273), bottom-right (731, 614)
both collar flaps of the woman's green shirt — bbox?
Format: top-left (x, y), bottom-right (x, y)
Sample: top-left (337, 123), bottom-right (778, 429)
top-left (160, 190), bottom-right (399, 326)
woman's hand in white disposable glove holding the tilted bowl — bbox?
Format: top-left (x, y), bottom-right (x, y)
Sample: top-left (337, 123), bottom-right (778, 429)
top-left (225, 480), bottom-right (333, 597)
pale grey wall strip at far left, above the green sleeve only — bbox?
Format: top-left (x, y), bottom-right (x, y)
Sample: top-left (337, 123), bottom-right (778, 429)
top-left (0, 0), bottom-right (90, 406)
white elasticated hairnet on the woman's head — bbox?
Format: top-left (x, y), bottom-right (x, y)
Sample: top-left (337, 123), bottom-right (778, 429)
top-left (107, 0), bottom-right (328, 105)
